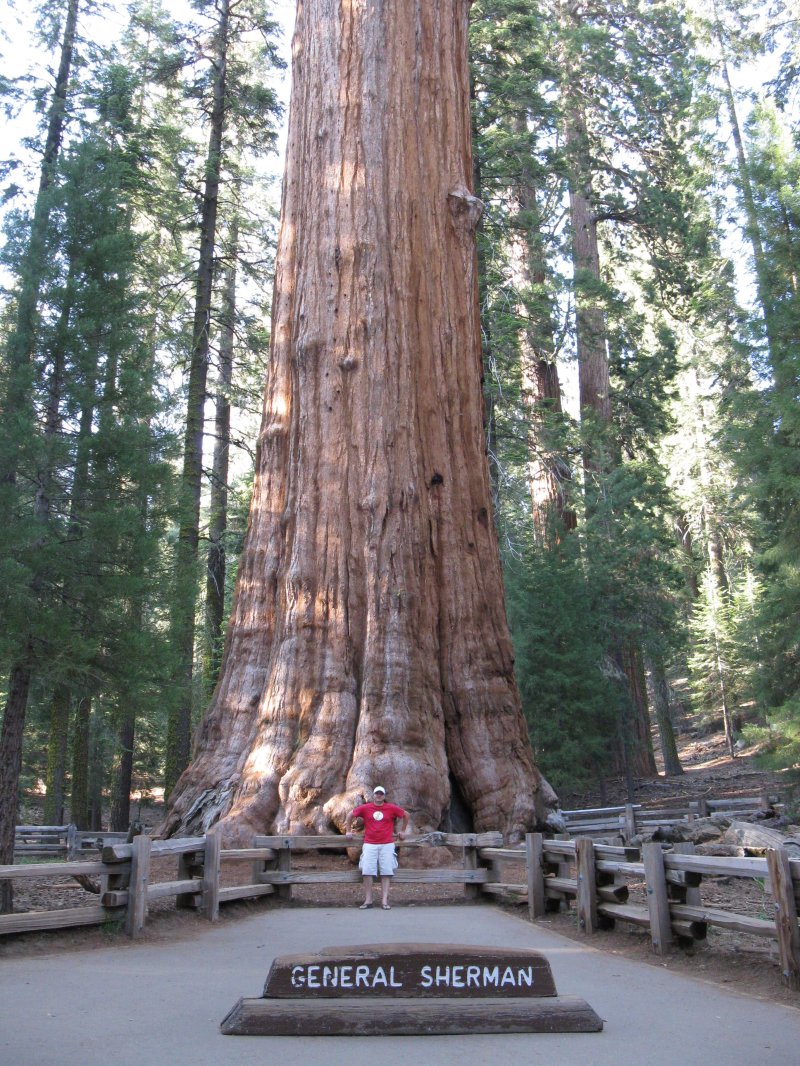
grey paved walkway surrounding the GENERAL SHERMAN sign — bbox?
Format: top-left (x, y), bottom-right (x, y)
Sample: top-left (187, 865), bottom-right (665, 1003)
top-left (0, 906), bottom-right (800, 1066)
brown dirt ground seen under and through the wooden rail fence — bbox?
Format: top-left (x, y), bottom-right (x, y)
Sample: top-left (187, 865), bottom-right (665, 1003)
top-left (6, 736), bottom-right (800, 1010)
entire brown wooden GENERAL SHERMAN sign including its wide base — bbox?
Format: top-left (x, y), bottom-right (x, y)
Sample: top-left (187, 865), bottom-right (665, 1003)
top-left (221, 943), bottom-right (603, 1036)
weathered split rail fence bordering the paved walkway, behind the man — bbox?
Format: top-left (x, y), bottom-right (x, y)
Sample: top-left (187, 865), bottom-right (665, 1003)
top-left (0, 831), bottom-right (800, 990)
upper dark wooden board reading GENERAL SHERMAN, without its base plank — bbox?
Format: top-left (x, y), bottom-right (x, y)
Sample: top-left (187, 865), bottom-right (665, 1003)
top-left (263, 943), bottom-right (556, 999)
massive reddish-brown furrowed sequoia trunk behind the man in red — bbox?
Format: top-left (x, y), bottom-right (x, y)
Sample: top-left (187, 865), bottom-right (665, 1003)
top-left (163, 0), bottom-right (555, 840)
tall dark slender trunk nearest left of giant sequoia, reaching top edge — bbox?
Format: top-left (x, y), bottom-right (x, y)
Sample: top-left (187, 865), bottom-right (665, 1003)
top-left (164, 0), bottom-right (230, 794)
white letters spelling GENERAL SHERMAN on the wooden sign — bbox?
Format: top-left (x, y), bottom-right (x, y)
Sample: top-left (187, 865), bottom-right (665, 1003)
top-left (290, 963), bottom-right (534, 989)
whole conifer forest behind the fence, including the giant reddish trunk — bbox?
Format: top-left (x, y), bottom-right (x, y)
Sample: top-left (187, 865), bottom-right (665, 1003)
top-left (0, 0), bottom-right (800, 863)
